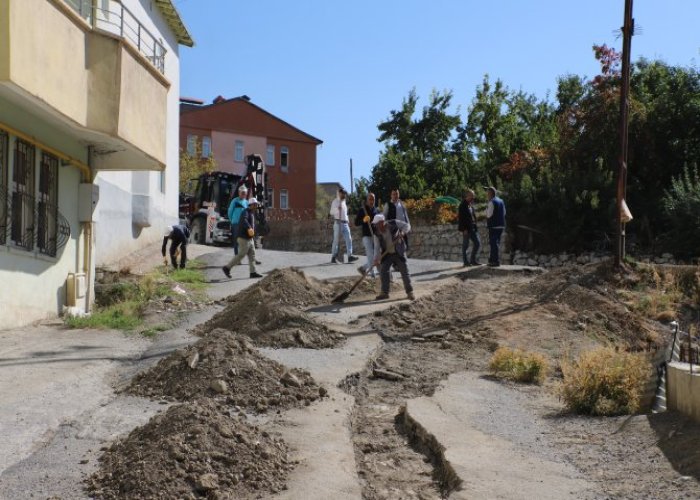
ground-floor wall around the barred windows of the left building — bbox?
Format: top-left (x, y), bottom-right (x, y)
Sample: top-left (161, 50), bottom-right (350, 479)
top-left (0, 98), bottom-right (87, 328)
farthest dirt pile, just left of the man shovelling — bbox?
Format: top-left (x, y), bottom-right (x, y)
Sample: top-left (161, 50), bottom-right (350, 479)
top-left (194, 268), bottom-right (344, 349)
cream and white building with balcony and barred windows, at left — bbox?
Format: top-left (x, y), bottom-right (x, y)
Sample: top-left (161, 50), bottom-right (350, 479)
top-left (0, 0), bottom-right (193, 328)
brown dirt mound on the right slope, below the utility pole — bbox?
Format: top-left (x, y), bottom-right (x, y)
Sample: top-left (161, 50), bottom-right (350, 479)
top-left (523, 261), bottom-right (662, 350)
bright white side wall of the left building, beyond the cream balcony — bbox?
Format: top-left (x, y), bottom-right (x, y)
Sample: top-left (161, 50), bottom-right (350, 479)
top-left (95, 0), bottom-right (185, 266)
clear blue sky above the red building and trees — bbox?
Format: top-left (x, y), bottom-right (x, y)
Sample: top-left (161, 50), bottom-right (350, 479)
top-left (174, 0), bottom-right (700, 187)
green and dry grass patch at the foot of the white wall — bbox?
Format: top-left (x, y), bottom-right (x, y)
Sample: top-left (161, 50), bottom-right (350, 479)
top-left (65, 260), bottom-right (207, 330)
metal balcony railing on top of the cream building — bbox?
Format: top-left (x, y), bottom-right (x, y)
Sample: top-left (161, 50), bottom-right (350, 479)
top-left (64, 0), bottom-right (166, 73)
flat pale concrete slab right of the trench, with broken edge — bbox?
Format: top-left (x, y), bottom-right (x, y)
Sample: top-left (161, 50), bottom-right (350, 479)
top-left (405, 372), bottom-right (596, 500)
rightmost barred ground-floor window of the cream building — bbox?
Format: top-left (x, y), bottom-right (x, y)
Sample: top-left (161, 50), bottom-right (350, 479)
top-left (37, 153), bottom-right (58, 257)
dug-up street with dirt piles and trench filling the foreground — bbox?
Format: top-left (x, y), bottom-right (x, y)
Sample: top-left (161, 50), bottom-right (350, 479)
top-left (0, 250), bottom-right (700, 499)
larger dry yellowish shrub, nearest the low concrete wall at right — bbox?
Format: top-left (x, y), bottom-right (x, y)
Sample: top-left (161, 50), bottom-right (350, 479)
top-left (561, 347), bottom-right (650, 415)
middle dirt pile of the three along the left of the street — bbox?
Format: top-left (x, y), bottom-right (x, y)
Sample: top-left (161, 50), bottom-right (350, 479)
top-left (126, 329), bottom-right (326, 412)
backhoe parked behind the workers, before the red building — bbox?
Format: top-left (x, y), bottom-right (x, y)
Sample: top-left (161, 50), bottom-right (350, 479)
top-left (180, 154), bottom-right (270, 245)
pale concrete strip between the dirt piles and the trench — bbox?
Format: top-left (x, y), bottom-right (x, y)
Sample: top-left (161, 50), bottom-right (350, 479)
top-left (260, 335), bottom-right (381, 500)
